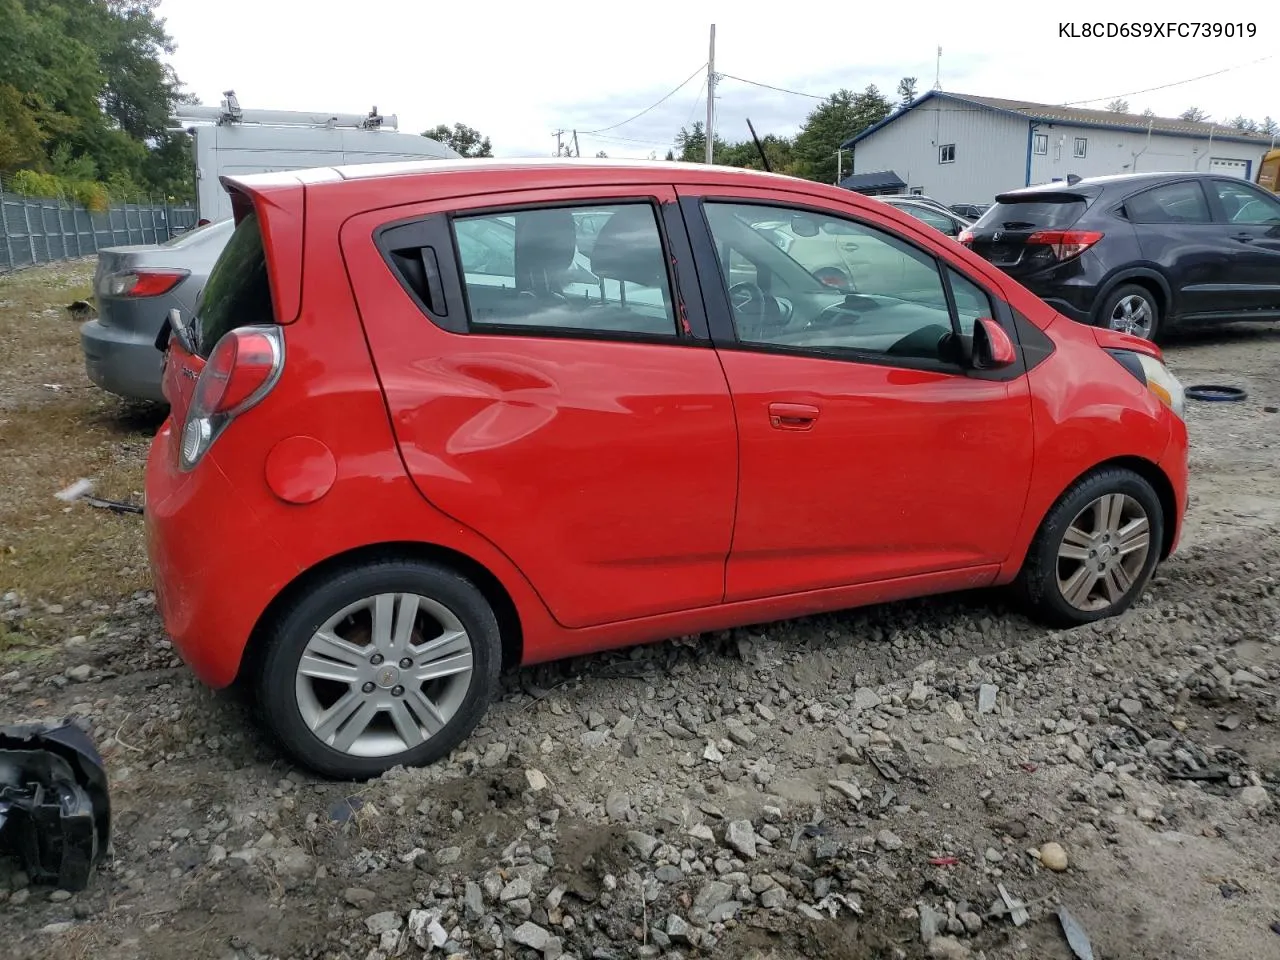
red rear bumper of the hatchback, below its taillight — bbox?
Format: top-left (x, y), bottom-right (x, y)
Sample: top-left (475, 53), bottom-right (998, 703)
top-left (145, 420), bottom-right (298, 689)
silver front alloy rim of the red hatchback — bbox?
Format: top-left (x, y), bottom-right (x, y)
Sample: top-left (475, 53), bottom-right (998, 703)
top-left (1057, 493), bottom-right (1151, 612)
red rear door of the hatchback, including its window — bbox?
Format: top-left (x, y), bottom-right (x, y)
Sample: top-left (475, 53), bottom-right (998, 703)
top-left (342, 187), bottom-right (737, 627)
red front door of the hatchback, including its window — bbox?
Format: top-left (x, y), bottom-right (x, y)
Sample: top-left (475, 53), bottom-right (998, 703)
top-left (677, 184), bottom-right (1032, 602)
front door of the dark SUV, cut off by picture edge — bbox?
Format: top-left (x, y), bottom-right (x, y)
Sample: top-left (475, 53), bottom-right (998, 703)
top-left (1207, 178), bottom-right (1280, 312)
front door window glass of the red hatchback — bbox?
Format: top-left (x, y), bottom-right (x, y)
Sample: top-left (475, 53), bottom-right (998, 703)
top-left (704, 202), bottom-right (962, 364)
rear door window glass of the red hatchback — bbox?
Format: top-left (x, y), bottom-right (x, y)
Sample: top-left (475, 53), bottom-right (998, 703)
top-left (453, 202), bottom-right (676, 337)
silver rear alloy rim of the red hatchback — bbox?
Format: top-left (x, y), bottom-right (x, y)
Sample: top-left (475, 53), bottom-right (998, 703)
top-left (294, 593), bottom-right (475, 758)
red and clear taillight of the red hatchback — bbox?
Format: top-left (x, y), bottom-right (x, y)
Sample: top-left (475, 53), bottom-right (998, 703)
top-left (178, 325), bottom-right (284, 470)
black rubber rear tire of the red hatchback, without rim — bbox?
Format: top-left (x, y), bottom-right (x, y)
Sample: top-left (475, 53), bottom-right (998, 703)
top-left (256, 559), bottom-right (502, 780)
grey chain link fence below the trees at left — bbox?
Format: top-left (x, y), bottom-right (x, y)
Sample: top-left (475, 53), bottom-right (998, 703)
top-left (0, 192), bottom-right (196, 274)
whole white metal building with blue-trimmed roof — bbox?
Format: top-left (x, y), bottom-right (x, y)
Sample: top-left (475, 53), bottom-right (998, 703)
top-left (841, 90), bottom-right (1274, 204)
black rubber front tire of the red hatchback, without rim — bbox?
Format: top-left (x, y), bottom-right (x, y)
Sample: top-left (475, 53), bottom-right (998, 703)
top-left (1015, 467), bottom-right (1165, 627)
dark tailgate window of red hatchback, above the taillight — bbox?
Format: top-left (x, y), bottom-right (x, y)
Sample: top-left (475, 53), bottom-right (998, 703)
top-left (196, 212), bottom-right (275, 360)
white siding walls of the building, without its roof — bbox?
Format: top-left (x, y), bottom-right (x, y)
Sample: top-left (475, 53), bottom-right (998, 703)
top-left (852, 100), bottom-right (1267, 204)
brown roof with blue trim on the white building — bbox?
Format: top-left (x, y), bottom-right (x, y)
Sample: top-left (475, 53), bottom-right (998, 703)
top-left (840, 90), bottom-right (1271, 150)
